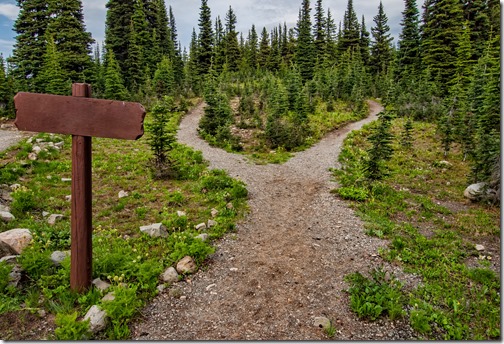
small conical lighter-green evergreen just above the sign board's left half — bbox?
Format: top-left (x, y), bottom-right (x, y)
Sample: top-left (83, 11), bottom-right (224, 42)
top-left (35, 32), bottom-right (72, 95)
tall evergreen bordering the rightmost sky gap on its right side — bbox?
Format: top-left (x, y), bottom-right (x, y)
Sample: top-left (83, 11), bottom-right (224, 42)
top-left (397, 0), bottom-right (420, 77)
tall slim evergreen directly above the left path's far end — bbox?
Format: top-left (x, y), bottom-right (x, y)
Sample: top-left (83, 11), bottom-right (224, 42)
top-left (197, 0), bottom-right (214, 75)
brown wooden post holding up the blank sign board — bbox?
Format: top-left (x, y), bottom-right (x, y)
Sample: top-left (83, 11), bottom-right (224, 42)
top-left (70, 84), bottom-right (93, 292)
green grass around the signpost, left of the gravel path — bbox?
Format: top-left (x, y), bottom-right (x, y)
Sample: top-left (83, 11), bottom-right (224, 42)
top-left (0, 105), bottom-right (247, 339)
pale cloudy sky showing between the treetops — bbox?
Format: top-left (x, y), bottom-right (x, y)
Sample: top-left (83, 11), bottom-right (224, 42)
top-left (0, 0), bottom-right (412, 57)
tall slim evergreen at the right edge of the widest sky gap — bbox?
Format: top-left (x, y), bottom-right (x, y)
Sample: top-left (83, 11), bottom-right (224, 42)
top-left (295, 0), bottom-right (315, 82)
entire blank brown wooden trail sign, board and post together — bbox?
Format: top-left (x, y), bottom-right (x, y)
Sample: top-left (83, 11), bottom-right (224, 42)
top-left (14, 84), bottom-right (145, 292)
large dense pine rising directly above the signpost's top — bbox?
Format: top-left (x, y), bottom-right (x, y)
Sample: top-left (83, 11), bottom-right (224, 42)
top-left (47, 0), bottom-right (95, 82)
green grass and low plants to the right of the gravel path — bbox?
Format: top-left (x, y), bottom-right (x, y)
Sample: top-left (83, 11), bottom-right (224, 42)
top-left (334, 119), bottom-right (501, 340)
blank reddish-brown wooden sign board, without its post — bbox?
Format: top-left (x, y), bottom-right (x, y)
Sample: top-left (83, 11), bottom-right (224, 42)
top-left (14, 92), bottom-right (145, 140)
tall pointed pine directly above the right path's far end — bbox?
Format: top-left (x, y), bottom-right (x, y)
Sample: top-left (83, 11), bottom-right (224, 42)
top-left (370, 1), bottom-right (392, 74)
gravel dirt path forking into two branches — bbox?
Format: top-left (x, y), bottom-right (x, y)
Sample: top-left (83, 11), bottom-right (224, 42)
top-left (131, 102), bottom-right (413, 340)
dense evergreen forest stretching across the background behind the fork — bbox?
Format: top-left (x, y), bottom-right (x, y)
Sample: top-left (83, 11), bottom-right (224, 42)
top-left (0, 0), bottom-right (500, 182)
